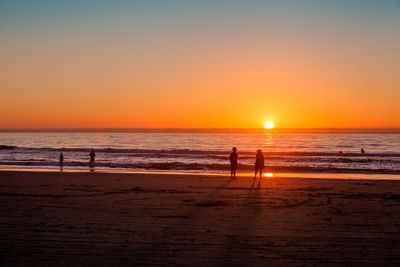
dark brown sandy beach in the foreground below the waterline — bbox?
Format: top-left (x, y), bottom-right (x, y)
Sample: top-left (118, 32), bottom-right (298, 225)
top-left (0, 171), bottom-right (400, 267)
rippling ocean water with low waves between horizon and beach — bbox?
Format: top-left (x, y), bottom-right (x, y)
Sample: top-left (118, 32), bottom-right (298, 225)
top-left (0, 131), bottom-right (400, 175)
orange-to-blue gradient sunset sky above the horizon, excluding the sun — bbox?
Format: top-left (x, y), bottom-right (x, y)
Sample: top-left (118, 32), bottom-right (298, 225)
top-left (0, 0), bottom-right (400, 128)
